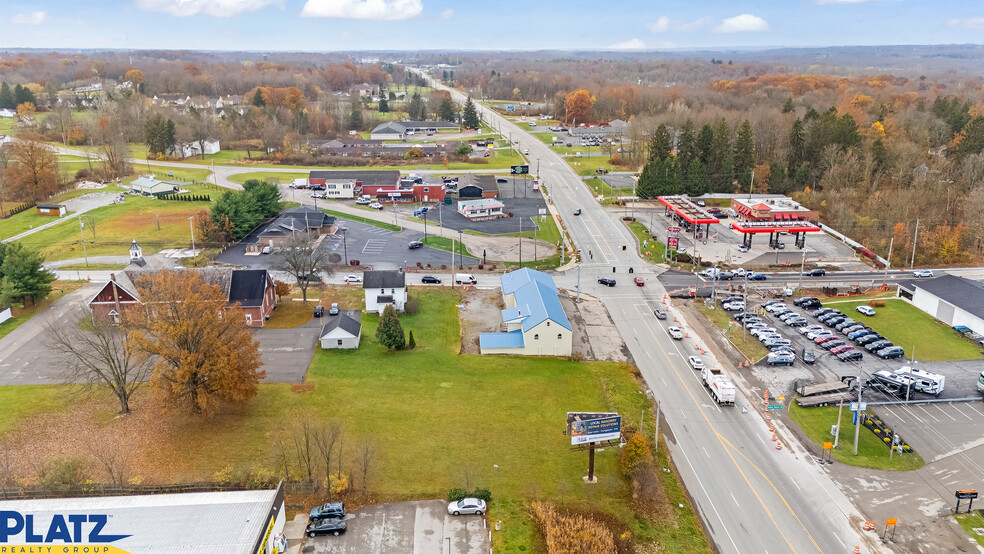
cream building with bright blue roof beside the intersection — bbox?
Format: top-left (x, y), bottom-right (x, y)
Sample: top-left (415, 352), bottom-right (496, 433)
top-left (479, 267), bottom-right (574, 356)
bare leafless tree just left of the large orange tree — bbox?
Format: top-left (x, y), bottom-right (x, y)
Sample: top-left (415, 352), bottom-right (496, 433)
top-left (43, 308), bottom-right (154, 414)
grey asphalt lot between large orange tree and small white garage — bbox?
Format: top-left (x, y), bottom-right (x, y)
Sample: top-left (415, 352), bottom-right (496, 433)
top-left (253, 317), bottom-right (323, 383)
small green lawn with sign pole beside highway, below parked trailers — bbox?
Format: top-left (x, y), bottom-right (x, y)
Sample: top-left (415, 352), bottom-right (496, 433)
top-left (787, 398), bottom-right (925, 471)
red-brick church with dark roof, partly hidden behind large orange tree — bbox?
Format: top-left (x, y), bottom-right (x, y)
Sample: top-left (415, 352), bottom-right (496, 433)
top-left (89, 266), bottom-right (277, 327)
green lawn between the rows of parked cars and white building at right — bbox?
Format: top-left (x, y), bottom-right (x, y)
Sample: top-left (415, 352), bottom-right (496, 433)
top-left (823, 298), bottom-right (984, 362)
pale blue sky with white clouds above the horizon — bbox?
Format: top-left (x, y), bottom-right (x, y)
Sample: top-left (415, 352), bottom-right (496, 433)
top-left (0, 0), bottom-right (984, 51)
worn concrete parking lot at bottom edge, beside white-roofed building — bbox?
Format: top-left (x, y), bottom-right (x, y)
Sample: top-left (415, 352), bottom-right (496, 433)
top-left (301, 500), bottom-right (491, 554)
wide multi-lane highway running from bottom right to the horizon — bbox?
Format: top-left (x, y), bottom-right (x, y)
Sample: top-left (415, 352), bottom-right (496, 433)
top-left (418, 70), bottom-right (883, 553)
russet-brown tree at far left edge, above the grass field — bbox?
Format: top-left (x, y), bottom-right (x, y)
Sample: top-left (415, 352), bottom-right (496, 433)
top-left (4, 134), bottom-right (58, 202)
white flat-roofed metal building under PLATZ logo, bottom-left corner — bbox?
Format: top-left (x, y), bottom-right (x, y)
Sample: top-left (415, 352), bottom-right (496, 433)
top-left (0, 484), bottom-right (286, 554)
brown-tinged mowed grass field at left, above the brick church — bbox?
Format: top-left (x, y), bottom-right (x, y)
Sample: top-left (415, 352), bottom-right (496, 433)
top-left (15, 196), bottom-right (214, 260)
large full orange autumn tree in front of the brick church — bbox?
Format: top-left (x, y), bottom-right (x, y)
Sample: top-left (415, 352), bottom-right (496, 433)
top-left (124, 270), bottom-right (266, 417)
